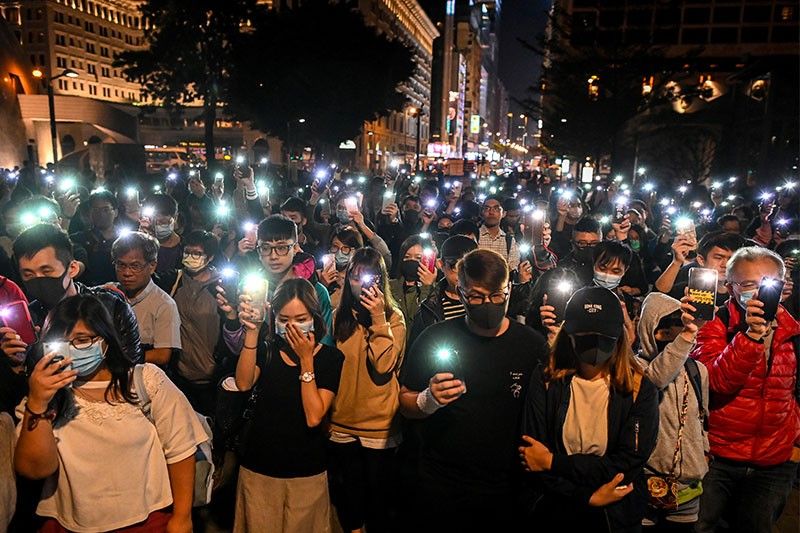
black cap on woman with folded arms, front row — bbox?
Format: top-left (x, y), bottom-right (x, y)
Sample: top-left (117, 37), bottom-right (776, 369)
top-left (564, 287), bottom-right (625, 339)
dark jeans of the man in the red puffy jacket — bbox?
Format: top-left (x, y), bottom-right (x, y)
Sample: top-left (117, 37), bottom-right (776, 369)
top-left (695, 460), bottom-right (798, 533)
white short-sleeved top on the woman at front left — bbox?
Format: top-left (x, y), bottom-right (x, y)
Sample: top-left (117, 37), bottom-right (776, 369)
top-left (17, 363), bottom-right (207, 532)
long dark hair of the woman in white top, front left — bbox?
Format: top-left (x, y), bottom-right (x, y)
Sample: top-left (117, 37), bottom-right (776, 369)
top-left (41, 294), bottom-right (137, 403)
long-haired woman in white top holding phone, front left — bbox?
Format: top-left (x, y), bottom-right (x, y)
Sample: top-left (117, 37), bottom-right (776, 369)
top-left (15, 296), bottom-right (207, 533)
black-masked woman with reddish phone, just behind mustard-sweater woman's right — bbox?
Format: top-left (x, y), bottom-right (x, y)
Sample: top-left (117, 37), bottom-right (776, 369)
top-left (389, 235), bottom-right (436, 330)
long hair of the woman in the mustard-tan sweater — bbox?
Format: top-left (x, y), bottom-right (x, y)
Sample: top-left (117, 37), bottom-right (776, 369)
top-left (333, 248), bottom-right (397, 342)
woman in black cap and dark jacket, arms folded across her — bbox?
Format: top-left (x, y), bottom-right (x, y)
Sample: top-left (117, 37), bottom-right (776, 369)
top-left (520, 287), bottom-right (658, 532)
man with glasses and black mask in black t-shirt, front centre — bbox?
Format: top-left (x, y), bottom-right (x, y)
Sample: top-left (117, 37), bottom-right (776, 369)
top-left (400, 249), bottom-right (547, 531)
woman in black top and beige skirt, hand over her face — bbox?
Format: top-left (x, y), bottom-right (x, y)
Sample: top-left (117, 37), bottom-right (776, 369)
top-left (234, 279), bottom-right (344, 532)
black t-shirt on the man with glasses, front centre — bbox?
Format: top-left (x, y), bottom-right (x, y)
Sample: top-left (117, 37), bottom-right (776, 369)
top-left (400, 319), bottom-right (547, 493)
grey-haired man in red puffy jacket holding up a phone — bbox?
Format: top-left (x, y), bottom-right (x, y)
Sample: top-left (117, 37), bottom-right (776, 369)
top-left (692, 246), bottom-right (800, 533)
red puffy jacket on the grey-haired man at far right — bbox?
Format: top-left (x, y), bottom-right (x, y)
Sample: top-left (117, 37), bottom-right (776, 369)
top-left (692, 301), bottom-right (800, 466)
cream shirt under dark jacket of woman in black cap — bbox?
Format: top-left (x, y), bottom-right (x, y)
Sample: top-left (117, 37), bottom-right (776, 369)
top-left (561, 376), bottom-right (610, 455)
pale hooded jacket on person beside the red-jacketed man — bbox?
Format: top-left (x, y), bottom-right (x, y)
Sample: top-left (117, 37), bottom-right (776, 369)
top-left (638, 292), bottom-right (708, 485)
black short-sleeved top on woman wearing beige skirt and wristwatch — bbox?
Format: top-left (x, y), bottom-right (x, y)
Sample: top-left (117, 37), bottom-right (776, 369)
top-left (242, 343), bottom-right (344, 478)
